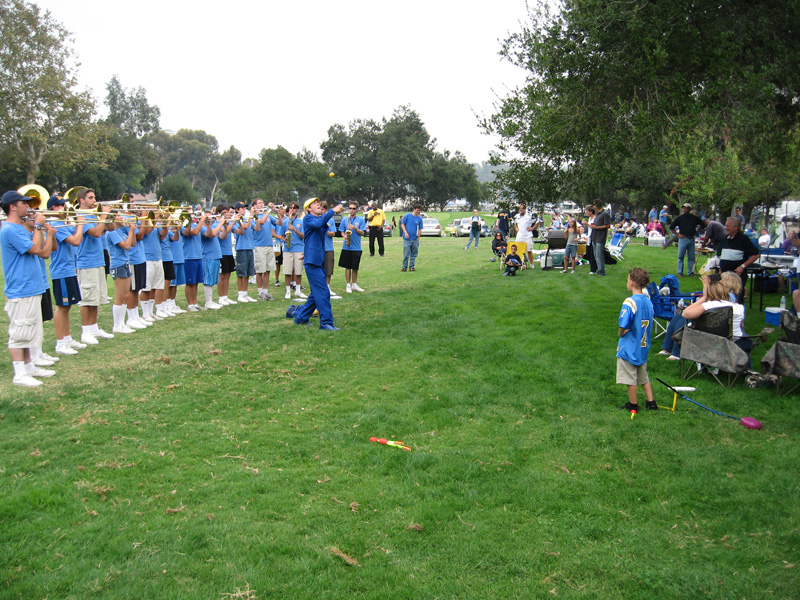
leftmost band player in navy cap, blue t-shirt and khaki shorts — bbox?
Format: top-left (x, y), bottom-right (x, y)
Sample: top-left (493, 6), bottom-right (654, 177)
top-left (0, 190), bottom-right (55, 387)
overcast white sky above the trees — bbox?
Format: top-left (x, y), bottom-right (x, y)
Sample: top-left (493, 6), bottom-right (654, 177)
top-left (33, 0), bottom-right (527, 162)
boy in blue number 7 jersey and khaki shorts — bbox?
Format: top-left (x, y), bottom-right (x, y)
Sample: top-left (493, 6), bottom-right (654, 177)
top-left (617, 267), bottom-right (658, 412)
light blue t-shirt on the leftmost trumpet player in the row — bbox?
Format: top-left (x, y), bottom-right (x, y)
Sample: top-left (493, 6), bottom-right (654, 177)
top-left (0, 223), bottom-right (47, 299)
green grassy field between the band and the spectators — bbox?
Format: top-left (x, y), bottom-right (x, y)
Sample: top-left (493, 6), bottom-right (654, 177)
top-left (0, 232), bottom-right (800, 600)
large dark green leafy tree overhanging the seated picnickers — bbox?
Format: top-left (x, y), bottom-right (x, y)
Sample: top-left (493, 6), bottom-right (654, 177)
top-left (483, 0), bottom-right (800, 213)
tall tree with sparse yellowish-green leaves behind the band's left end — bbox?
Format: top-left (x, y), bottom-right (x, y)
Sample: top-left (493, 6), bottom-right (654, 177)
top-left (0, 0), bottom-right (116, 183)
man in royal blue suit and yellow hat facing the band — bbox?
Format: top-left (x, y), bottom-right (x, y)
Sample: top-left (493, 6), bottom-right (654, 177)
top-left (294, 198), bottom-right (342, 331)
